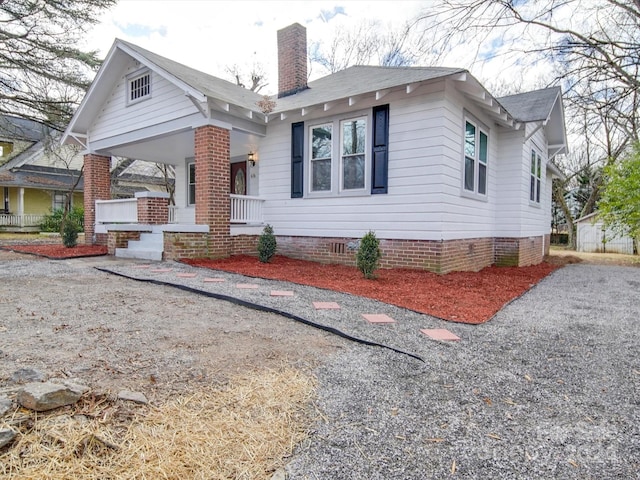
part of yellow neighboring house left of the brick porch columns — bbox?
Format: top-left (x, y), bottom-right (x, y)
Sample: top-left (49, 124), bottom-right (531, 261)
top-left (0, 116), bottom-right (83, 231)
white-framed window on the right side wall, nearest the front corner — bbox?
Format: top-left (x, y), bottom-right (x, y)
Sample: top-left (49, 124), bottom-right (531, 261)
top-left (462, 119), bottom-right (489, 197)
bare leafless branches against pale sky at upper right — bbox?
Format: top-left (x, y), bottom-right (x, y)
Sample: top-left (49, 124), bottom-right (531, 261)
top-left (412, 0), bottom-right (640, 245)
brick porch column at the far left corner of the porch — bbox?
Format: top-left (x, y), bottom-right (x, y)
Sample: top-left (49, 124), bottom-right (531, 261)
top-left (84, 153), bottom-right (111, 245)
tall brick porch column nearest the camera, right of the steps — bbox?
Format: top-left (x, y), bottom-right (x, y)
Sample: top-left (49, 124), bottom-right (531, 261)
top-left (195, 125), bottom-right (231, 258)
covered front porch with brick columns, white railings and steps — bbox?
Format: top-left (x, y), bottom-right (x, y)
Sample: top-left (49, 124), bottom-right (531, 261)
top-left (79, 125), bottom-right (264, 260)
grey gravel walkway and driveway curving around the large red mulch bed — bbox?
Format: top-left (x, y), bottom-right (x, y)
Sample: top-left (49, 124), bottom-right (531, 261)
top-left (2, 253), bottom-right (640, 480)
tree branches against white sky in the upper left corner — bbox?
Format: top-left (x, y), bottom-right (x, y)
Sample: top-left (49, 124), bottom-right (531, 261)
top-left (0, 0), bottom-right (115, 130)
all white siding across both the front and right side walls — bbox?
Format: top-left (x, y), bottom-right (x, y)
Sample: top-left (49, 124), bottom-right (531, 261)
top-left (259, 82), bottom-right (551, 244)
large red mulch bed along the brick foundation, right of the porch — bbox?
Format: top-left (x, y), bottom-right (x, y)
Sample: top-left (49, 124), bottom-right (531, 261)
top-left (184, 255), bottom-right (558, 324)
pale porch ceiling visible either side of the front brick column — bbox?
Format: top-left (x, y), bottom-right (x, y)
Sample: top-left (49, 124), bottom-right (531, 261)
top-left (99, 130), bottom-right (258, 165)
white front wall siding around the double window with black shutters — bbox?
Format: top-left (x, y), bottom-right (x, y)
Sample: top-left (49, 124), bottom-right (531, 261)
top-left (259, 82), bottom-right (452, 240)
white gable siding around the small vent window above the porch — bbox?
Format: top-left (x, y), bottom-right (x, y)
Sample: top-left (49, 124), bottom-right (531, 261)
top-left (90, 60), bottom-right (197, 141)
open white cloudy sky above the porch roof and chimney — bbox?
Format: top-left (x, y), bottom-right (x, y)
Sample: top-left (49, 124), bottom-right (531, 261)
top-left (87, 0), bottom-right (430, 93)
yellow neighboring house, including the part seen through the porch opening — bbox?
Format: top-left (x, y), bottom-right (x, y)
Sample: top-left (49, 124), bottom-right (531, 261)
top-left (0, 115), bottom-right (175, 231)
